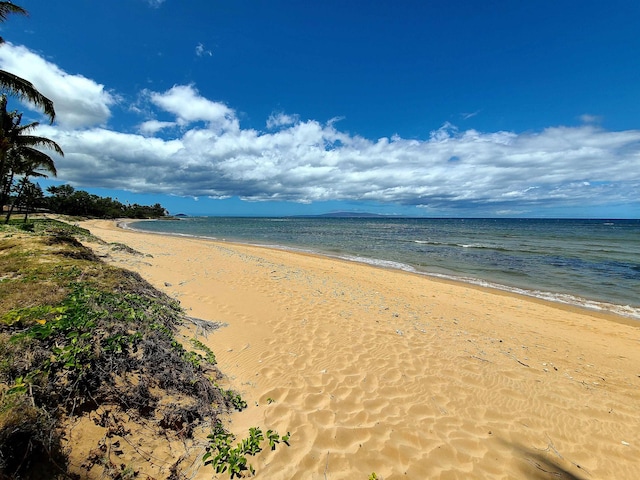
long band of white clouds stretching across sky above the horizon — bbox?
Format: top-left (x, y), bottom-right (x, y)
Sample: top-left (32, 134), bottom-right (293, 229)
top-left (0, 44), bottom-right (640, 215)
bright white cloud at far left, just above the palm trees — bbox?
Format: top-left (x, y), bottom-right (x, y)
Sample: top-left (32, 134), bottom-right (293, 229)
top-left (0, 43), bottom-right (117, 128)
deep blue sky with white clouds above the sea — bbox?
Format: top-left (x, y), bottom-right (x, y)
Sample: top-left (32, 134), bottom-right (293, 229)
top-left (0, 0), bottom-right (640, 218)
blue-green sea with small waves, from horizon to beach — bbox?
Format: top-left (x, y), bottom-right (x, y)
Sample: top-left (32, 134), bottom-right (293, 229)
top-left (131, 217), bottom-right (640, 319)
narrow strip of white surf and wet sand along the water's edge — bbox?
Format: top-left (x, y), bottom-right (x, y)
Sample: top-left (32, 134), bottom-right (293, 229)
top-left (121, 219), bottom-right (640, 327)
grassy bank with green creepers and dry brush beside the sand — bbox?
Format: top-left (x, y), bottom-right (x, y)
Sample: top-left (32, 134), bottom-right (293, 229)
top-left (0, 221), bottom-right (248, 478)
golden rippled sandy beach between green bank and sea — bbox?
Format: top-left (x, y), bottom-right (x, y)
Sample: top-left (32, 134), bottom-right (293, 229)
top-left (81, 220), bottom-right (640, 480)
